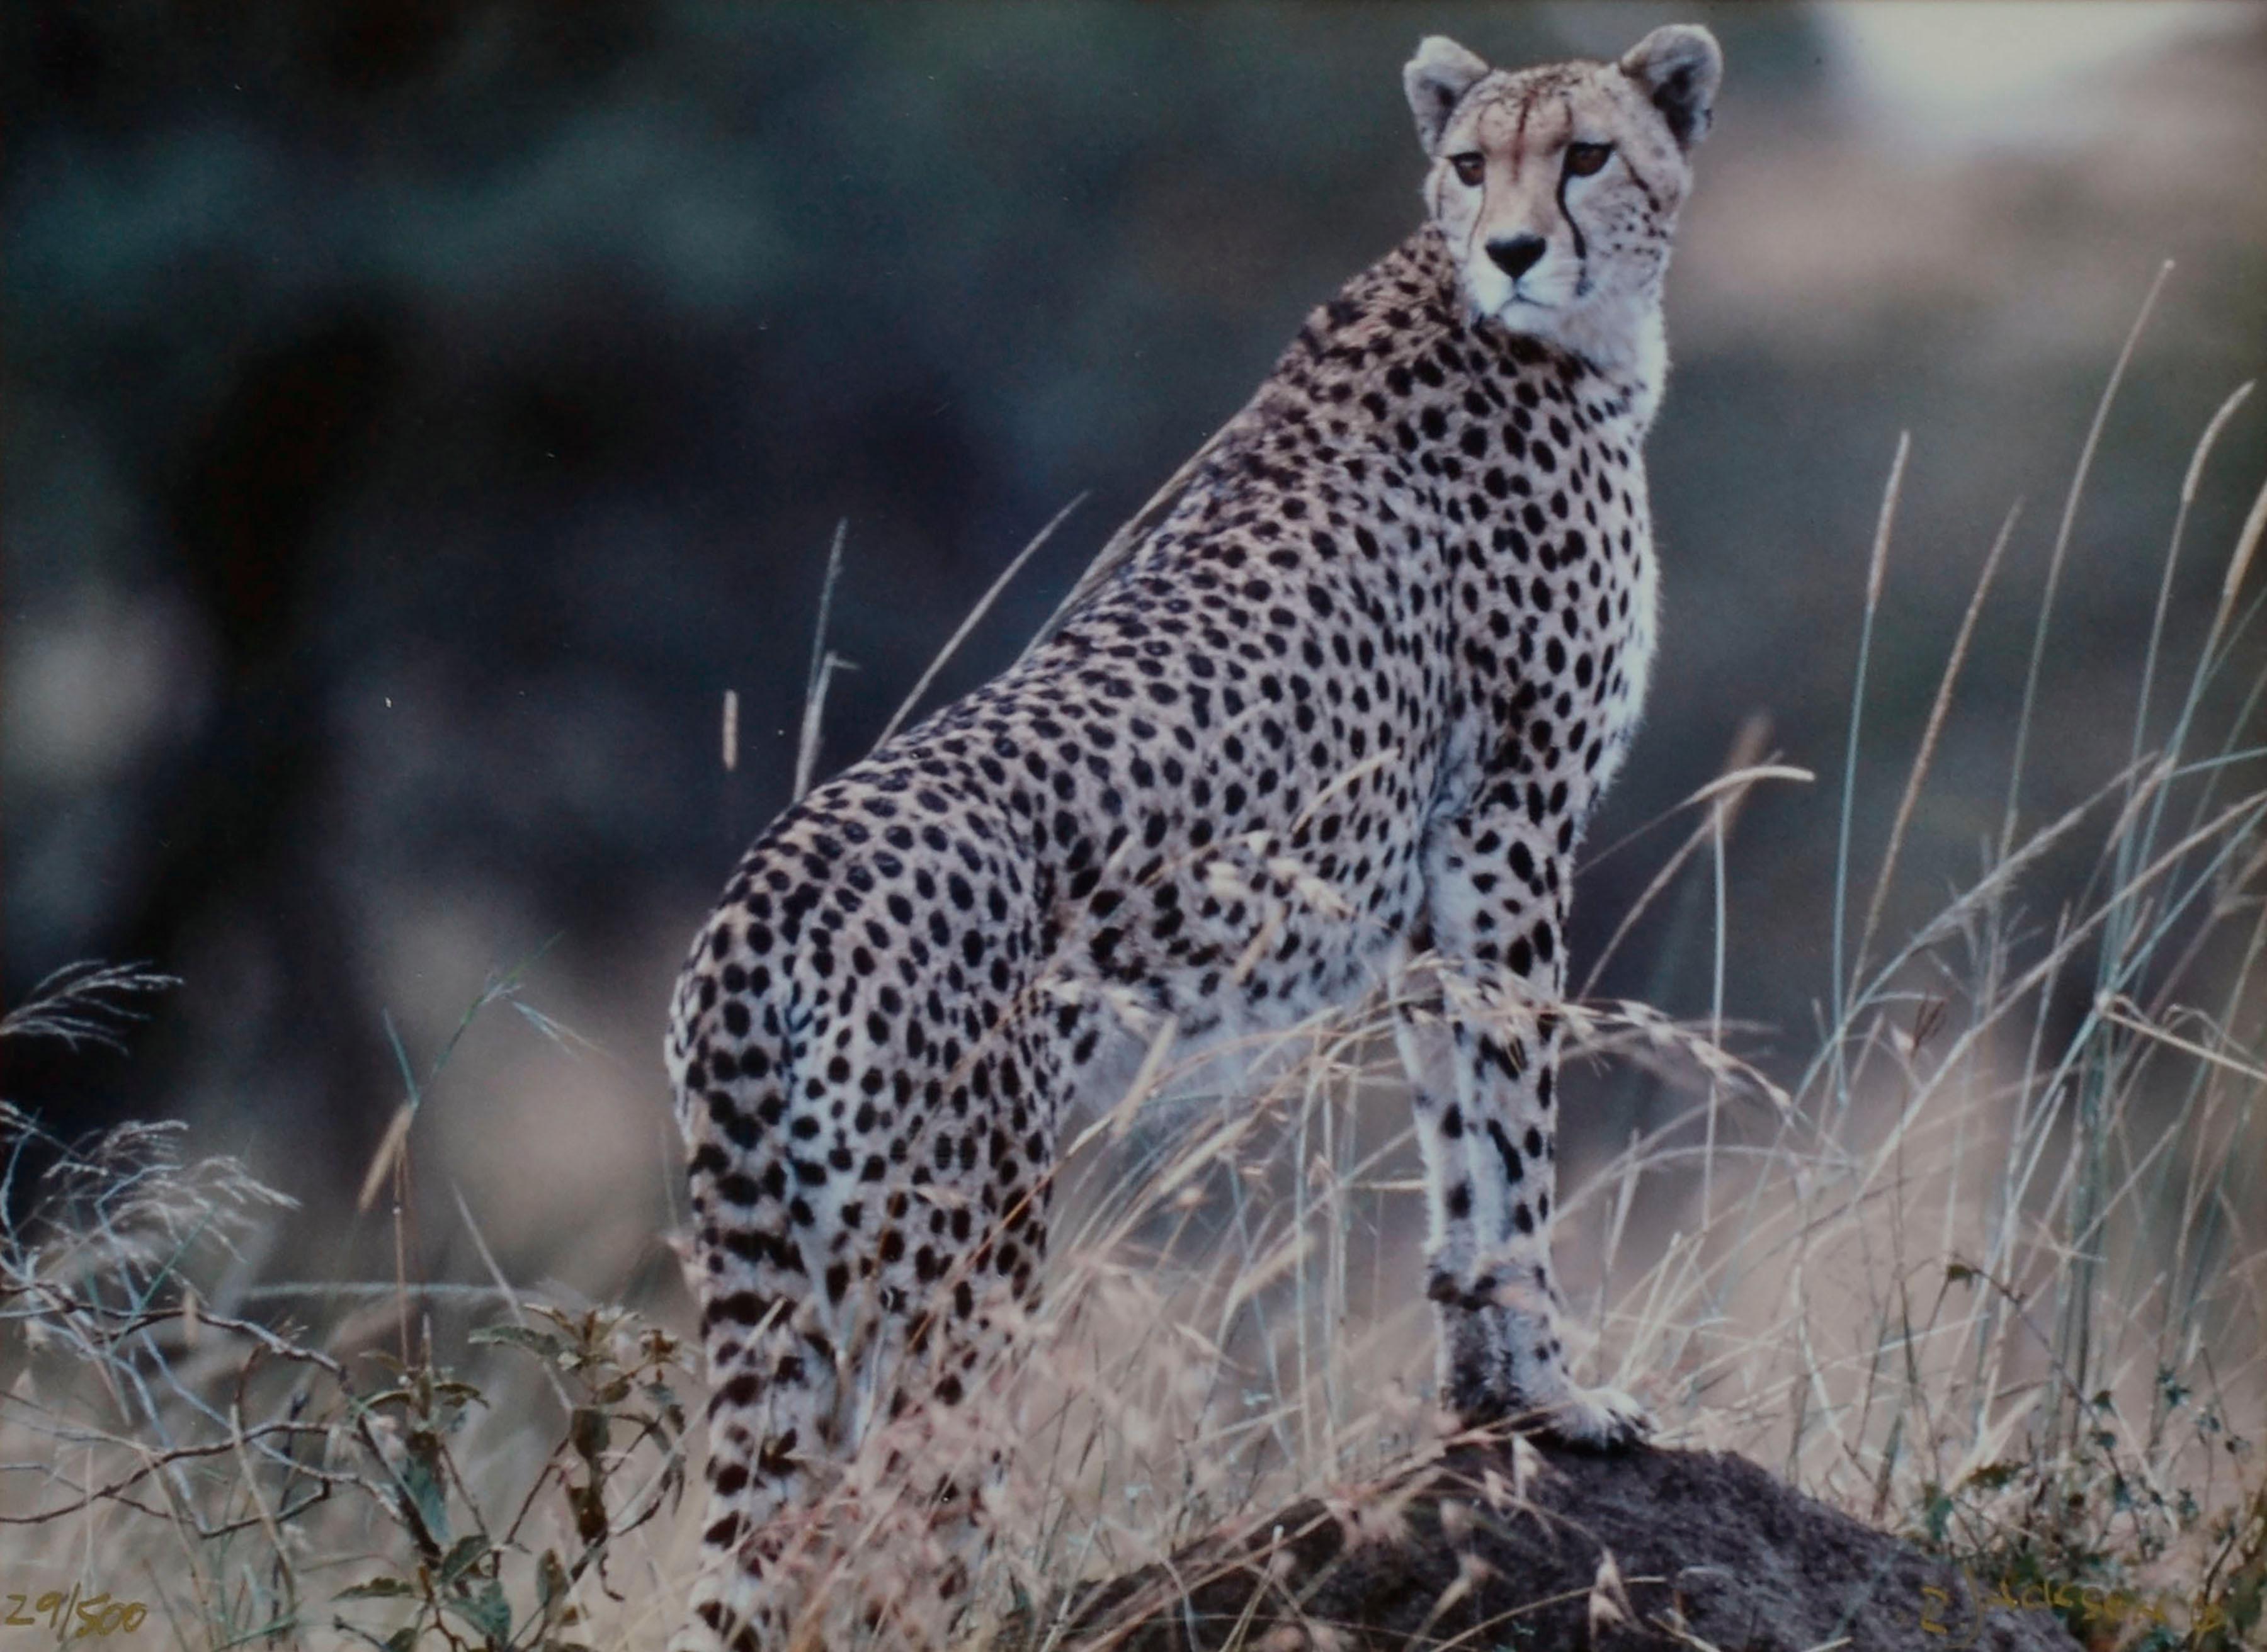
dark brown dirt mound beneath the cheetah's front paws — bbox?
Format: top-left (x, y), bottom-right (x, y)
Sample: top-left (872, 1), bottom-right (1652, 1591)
top-left (1038, 1444), bottom-right (2077, 1652)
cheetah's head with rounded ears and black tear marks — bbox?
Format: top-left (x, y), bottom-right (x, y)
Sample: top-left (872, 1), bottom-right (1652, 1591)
top-left (1401, 25), bottom-right (1723, 370)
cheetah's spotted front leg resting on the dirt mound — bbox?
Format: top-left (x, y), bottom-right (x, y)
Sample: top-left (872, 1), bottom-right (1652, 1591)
top-left (1399, 784), bottom-right (1652, 1448)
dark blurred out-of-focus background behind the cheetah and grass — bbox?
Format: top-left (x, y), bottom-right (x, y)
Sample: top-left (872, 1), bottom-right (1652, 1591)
top-left (0, 0), bottom-right (2267, 1271)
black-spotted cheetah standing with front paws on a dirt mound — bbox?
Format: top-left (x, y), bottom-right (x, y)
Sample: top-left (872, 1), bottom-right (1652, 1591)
top-left (666, 25), bottom-right (1723, 1648)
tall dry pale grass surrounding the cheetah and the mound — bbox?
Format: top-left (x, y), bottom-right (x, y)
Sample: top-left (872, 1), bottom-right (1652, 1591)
top-left (0, 328), bottom-right (2267, 1652)
